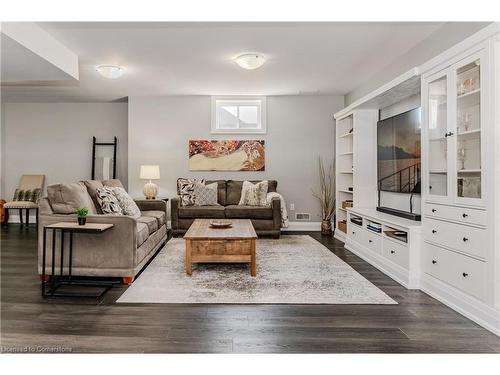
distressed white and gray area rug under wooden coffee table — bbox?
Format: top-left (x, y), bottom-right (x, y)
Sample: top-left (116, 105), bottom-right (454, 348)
top-left (117, 235), bottom-right (396, 304)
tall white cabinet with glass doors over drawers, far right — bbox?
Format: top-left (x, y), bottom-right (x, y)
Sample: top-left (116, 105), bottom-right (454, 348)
top-left (421, 38), bottom-right (500, 333)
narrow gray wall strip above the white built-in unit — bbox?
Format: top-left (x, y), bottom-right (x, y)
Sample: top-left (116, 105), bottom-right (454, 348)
top-left (345, 22), bottom-right (491, 105)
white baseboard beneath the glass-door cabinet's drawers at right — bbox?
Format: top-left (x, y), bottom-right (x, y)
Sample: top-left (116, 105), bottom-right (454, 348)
top-left (420, 274), bottom-right (500, 336)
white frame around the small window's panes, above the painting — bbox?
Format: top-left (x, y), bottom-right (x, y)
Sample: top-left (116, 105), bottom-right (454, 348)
top-left (211, 96), bottom-right (267, 134)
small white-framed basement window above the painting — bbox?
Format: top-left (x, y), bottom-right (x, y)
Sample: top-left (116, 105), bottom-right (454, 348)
top-left (212, 96), bottom-right (266, 134)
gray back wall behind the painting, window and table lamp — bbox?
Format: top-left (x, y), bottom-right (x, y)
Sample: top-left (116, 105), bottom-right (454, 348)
top-left (128, 96), bottom-right (344, 221)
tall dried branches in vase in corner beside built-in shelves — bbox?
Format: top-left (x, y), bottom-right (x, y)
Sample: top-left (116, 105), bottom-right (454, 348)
top-left (313, 157), bottom-right (335, 235)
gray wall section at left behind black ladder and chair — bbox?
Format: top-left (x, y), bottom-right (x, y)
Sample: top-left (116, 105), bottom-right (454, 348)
top-left (2, 103), bottom-right (128, 200)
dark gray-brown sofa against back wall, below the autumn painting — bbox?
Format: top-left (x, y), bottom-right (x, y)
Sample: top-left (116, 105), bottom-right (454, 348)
top-left (171, 180), bottom-right (281, 238)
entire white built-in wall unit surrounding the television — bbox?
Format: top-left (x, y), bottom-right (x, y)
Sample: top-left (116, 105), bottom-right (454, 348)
top-left (335, 23), bottom-right (500, 335)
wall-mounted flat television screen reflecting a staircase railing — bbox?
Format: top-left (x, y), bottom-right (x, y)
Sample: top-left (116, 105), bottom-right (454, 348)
top-left (377, 108), bottom-right (421, 193)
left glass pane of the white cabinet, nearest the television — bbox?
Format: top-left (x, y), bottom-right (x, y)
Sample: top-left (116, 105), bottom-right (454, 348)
top-left (427, 76), bottom-right (448, 196)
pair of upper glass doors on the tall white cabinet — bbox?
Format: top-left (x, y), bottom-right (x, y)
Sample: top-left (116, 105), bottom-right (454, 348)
top-left (422, 52), bottom-right (484, 205)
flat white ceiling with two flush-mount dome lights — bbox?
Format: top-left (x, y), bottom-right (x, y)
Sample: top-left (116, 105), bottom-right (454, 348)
top-left (2, 22), bottom-right (444, 102)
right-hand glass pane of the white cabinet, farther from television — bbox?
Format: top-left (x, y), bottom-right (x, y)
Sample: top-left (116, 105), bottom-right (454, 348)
top-left (456, 59), bottom-right (481, 199)
